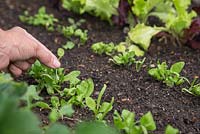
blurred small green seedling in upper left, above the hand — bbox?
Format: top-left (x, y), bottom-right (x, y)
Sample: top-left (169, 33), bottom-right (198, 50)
top-left (19, 7), bottom-right (58, 31)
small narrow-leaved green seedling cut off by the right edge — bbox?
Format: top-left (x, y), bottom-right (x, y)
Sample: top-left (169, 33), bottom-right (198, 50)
top-left (182, 78), bottom-right (200, 96)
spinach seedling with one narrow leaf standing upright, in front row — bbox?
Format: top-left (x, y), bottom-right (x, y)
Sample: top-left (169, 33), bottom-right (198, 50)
top-left (86, 85), bottom-right (114, 121)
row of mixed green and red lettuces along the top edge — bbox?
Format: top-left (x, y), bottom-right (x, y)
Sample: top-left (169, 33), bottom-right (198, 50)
top-left (59, 0), bottom-right (199, 51)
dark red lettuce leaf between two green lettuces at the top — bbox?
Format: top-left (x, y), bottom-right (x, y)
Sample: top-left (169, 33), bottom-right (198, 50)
top-left (112, 0), bottom-right (131, 26)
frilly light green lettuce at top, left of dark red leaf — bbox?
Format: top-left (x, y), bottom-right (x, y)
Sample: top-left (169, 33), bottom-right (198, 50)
top-left (62, 0), bottom-right (119, 22)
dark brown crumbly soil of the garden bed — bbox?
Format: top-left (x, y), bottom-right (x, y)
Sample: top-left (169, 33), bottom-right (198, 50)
top-left (0, 0), bottom-right (200, 134)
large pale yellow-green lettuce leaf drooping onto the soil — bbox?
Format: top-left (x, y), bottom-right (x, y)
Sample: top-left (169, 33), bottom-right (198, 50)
top-left (128, 24), bottom-right (161, 51)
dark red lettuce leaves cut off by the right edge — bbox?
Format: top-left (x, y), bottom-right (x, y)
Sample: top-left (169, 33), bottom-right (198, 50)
top-left (184, 18), bottom-right (200, 49)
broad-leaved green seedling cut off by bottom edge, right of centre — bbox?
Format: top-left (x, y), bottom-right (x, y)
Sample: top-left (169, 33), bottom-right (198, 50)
top-left (113, 109), bottom-right (156, 134)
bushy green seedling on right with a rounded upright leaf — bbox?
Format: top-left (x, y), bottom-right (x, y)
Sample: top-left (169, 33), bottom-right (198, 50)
top-left (148, 62), bottom-right (188, 87)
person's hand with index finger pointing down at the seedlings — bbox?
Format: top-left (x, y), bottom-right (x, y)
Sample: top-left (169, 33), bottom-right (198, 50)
top-left (0, 27), bottom-right (60, 76)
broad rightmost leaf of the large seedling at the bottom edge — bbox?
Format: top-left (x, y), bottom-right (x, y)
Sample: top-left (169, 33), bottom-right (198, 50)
top-left (140, 112), bottom-right (156, 131)
